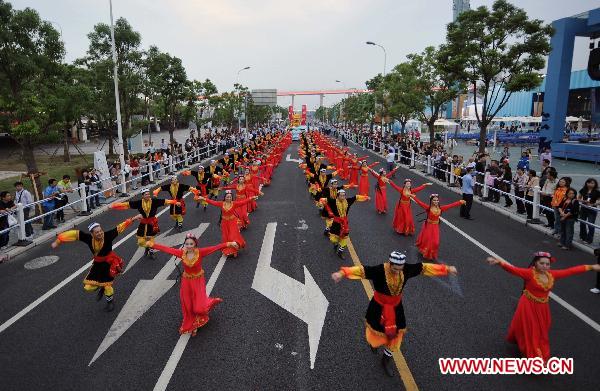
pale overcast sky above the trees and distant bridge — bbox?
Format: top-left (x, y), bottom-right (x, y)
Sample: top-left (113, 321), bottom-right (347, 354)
top-left (9, 0), bottom-right (598, 109)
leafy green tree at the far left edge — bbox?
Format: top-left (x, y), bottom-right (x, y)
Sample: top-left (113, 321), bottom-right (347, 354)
top-left (0, 0), bottom-right (65, 195)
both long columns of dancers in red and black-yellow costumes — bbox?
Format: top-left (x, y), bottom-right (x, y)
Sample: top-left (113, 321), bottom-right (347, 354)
top-left (52, 126), bottom-right (600, 376)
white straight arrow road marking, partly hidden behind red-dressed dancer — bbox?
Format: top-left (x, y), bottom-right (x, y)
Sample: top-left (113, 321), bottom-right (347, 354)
top-left (88, 223), bottom-right (209, 366)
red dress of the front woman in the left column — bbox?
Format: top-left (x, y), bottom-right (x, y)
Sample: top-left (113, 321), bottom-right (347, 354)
top-left (152, 243), bottom-right (227, 334)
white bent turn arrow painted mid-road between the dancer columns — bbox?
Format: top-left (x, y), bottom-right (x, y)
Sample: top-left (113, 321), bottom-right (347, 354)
top-left (252, 223), bottom-right (329, 369)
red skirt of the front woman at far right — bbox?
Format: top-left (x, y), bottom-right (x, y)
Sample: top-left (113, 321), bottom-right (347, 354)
top-left (506, 295), bottom-right (552, 361)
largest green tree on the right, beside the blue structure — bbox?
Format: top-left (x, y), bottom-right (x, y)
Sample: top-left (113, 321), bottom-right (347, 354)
top-left (443, 0), bottom-right (553, 152)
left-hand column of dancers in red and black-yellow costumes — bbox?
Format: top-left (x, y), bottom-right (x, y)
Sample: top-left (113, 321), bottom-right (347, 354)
top-left (52, 130), bottom-right (291, 335)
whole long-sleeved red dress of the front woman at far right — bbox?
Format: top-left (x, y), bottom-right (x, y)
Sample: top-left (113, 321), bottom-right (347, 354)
top-left (500, 262), bottom-right (590, 361)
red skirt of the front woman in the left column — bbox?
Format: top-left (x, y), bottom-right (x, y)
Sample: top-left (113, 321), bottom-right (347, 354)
top-left (179, 276), bottom-right (223, 334)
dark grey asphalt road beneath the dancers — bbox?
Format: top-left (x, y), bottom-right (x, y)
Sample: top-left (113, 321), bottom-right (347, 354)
top-left (0, 137), bottom-right (600, 390)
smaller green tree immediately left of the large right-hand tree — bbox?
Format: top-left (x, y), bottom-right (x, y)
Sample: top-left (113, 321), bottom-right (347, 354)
top-left (407, 46), bottom-right (462, 140)
